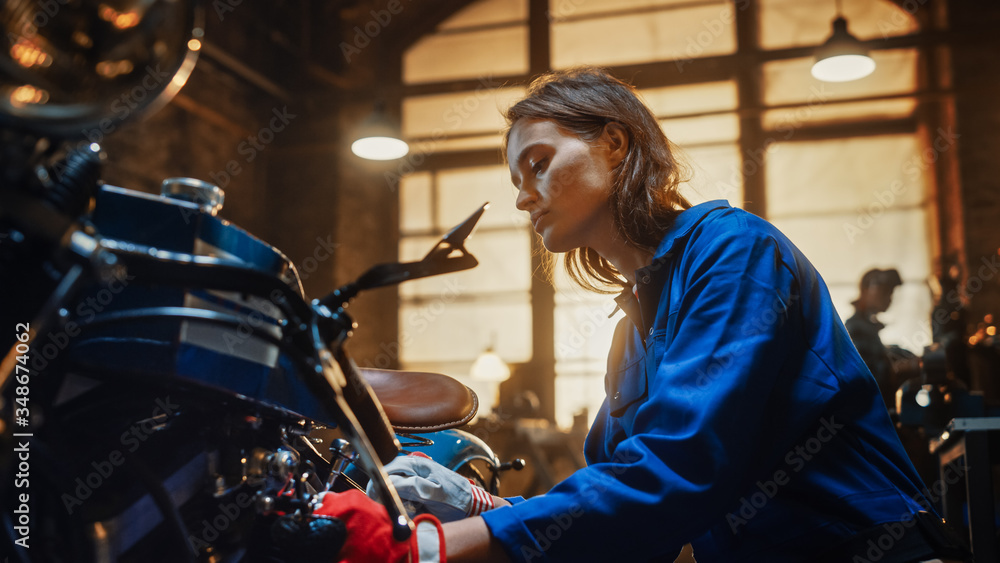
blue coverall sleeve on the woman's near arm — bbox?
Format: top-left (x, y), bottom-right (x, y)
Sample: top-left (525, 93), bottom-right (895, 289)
top-left (484, 217), bottom-right (803, 562)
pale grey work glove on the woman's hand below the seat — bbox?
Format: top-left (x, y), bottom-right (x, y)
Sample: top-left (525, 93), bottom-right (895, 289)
top-left (367, 455), bottom-right (495, 522)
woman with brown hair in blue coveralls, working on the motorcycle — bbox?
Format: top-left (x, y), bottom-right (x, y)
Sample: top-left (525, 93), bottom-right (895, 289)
top-left (316, 69), bottom-right (964, 563)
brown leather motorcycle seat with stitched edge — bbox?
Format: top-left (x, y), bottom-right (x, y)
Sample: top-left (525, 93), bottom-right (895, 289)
top-left (360, 368), bottom-right (479, 433)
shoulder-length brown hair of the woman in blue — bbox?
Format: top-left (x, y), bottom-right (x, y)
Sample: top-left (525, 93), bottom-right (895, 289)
top-left (503, 67), bottom-right (691, 293)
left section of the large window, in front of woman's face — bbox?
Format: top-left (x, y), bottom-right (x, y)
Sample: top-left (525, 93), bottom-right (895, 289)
top-left (399, 0), bottom-right (532, 411)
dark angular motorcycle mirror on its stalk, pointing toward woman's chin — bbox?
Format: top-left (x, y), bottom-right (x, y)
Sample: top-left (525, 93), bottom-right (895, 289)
top-left (320, 202), bottom-right (490, 308)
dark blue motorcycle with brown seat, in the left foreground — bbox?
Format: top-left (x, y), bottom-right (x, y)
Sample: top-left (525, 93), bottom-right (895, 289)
top-left (0, 0), bottom-right (516, 562)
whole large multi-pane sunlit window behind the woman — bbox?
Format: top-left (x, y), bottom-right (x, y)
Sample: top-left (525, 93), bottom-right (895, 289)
top-left (400, 0), bottom-right (937, 426)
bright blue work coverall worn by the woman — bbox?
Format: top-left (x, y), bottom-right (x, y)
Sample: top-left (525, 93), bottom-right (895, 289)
top-left (483, 201), bottom-right (930, 563)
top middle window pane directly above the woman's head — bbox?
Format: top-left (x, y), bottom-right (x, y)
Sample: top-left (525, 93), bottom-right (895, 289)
top-left (552, 1), bottom-right (736, 68)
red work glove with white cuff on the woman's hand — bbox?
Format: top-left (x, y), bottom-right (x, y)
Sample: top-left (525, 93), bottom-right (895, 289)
top-left (313, 490), bottom-right (445, 563)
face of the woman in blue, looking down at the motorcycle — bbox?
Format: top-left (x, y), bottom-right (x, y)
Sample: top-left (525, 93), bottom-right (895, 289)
top-left (507, 119), bottom-right (621, 255)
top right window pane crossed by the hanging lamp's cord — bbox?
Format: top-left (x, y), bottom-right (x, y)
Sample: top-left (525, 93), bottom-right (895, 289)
top-left (756, 0), bottom-right (918, 49)
